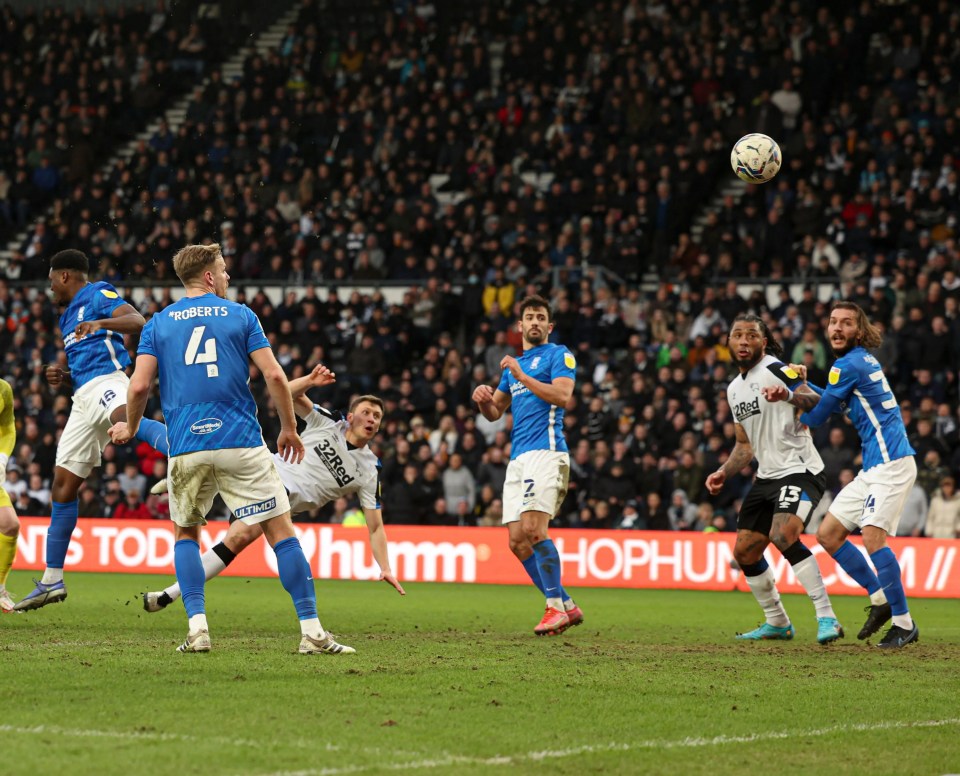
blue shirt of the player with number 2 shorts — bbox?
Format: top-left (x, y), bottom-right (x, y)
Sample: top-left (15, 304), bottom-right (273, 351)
top-left (498, 342), bottom-right (577, 460)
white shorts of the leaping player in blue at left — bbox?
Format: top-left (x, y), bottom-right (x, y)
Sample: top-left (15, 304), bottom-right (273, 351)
top-left (57, 370), bottom-right (130, 479)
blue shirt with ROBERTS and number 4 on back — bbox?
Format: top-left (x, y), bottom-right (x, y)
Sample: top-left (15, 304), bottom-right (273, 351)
top-left (137, 294), bottom-right (270, 457)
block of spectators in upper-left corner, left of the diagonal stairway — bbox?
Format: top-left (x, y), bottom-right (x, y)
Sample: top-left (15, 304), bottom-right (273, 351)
top-left (0, 0), bottom-right (255, 249)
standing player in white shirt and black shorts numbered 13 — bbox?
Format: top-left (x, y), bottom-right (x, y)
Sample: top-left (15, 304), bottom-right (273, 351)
top-left (706, 314), bottom-right (843, 644)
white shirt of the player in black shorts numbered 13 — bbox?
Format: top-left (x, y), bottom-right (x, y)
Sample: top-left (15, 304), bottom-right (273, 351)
top-left (727, 356), bottom-right (823, 480)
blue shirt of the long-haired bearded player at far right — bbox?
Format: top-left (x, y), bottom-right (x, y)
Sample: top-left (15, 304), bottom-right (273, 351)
top-left (800, 347), bottom-right (916, 471)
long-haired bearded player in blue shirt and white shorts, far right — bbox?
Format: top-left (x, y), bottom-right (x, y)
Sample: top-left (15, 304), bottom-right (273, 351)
top-left (767, 302), bottom-right (920, 649)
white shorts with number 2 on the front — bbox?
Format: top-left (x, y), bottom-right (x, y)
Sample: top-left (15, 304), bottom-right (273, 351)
top-left (503, 450), bottom-right (570, 525)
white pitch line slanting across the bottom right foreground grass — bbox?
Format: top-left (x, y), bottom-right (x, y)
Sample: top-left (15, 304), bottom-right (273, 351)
top-left (258, 718), bottom-right (960, 776)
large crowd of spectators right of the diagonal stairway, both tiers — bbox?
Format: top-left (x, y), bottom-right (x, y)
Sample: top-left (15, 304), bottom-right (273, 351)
top-left (0, 0), bottom-right (960, 533)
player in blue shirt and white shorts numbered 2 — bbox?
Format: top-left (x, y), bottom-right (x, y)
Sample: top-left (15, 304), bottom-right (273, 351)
top-left (473, 296), bottom-right (583, 636)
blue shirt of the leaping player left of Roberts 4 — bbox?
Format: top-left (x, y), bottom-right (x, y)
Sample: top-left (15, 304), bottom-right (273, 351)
top-left (60, 281), bottom-right (130, 391)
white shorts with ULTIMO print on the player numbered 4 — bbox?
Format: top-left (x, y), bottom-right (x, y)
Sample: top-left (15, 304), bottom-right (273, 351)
top-left (167, 445), bottom-right (290, 528)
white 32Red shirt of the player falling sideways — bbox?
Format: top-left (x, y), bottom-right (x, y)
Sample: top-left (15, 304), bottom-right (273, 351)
top-left (274, 404), bottom-right (380, 514)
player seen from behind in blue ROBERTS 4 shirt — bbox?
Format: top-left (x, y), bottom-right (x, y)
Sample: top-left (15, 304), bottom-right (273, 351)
top-left (112, 244), bottom-right (356, 654)
